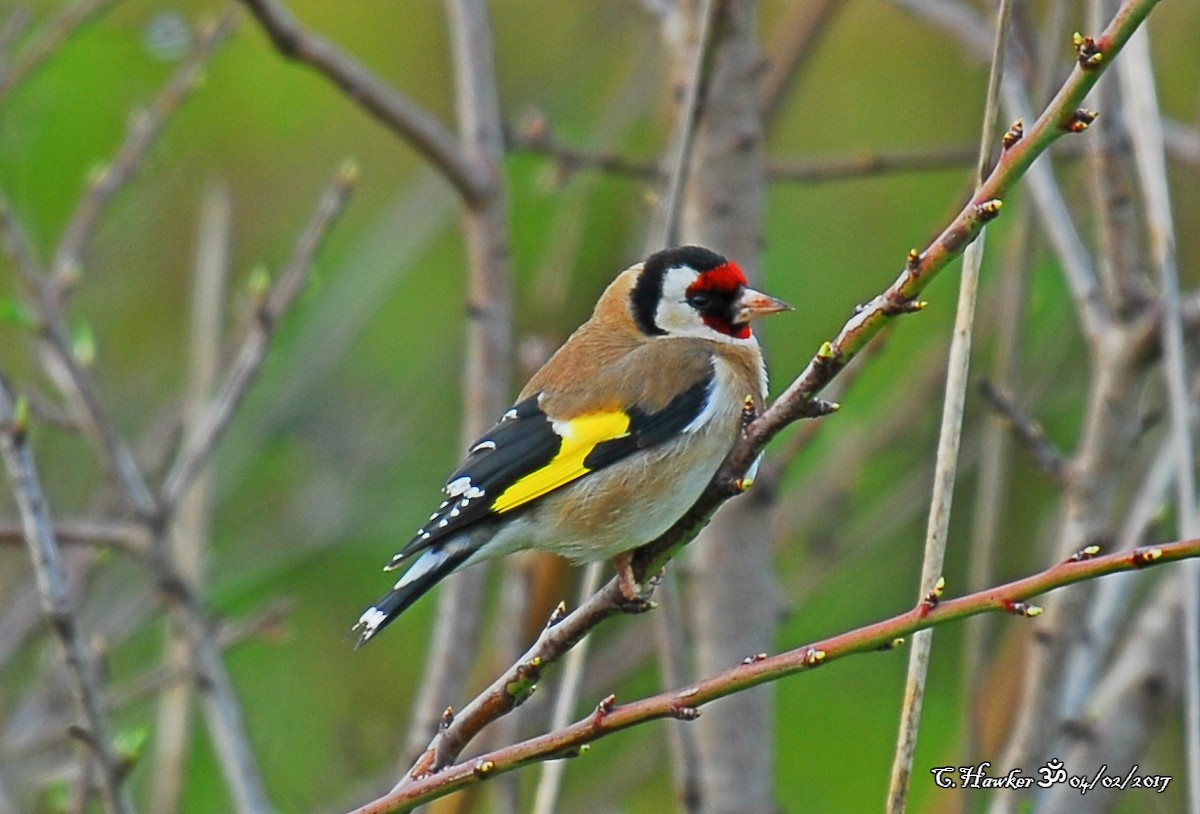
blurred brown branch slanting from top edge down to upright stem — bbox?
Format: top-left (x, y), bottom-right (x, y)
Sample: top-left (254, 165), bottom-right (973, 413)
top-left (241, 0), bottom-right (497, 204)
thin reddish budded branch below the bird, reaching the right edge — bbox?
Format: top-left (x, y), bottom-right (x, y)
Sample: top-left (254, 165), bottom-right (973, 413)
top-left (353, 539), bottom-right (1200, 814)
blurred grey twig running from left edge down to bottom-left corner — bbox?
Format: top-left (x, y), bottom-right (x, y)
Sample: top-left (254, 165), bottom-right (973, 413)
top-left (0, 379), bottom-right (133, 814)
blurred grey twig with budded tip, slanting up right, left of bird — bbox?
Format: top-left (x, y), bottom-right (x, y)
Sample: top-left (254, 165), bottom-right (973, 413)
top-left (161, 162), bottom-right (358, 514)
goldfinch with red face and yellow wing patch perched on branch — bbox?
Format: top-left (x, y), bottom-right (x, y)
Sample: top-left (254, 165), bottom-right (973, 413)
top-left (352, 246), bottom-right (792, 647)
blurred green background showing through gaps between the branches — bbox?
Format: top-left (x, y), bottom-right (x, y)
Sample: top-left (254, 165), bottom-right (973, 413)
top-left (0, 0), bottom-right (1200, 814)
